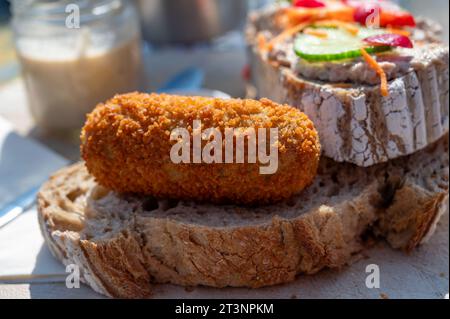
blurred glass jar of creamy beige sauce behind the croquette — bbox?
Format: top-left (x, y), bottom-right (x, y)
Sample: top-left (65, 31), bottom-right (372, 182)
top-left (12, 0), bottom-right (142, 132)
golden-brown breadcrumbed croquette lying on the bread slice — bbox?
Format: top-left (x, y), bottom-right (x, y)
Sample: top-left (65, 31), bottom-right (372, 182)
top-left (81, 93), bottom-right (320, 204)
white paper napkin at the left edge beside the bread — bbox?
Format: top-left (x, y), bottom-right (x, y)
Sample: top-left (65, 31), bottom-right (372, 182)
top-left (0, 117), bottom-right (68, 282)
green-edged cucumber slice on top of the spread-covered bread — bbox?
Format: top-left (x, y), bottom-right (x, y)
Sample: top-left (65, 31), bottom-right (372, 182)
top-left (294, 28), bottom-right (390, 62)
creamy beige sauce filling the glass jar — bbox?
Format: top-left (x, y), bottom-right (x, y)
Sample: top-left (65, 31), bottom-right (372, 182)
top-left (18, 37), bottom-right (141, 130)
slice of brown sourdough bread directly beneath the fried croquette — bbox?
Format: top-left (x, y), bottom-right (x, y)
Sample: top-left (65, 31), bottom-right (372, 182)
top-left (38, 137), bottom-right (449, 298)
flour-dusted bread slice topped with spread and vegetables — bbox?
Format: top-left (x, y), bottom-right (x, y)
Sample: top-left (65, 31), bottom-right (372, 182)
top-left (246, 7), bottom-right (449, 167)
